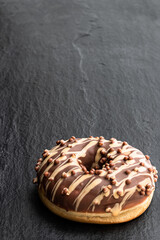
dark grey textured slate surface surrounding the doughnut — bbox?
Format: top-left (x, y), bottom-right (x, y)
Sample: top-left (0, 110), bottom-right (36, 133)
top-left (0, 0), bottom-right (160, 240)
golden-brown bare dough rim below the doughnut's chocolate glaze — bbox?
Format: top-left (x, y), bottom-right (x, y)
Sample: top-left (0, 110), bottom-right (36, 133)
top-left (38, 188), bottom-right (154, 224)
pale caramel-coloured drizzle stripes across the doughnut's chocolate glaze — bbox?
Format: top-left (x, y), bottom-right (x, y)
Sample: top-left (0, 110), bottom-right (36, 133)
top-left (38, 138), bottom-right (155, 216)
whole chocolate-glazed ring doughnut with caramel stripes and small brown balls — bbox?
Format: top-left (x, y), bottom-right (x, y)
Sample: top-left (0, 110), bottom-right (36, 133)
top-left (33, 136), bottom-right (158, 224)
